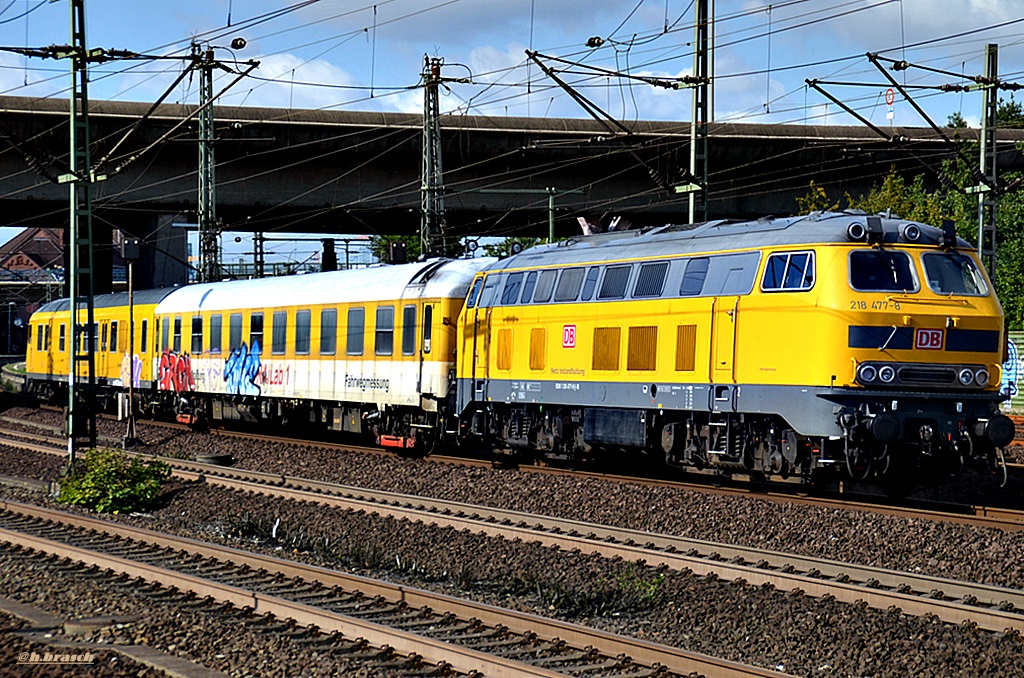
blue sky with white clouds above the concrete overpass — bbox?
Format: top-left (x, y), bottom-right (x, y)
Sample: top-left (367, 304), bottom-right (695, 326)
top-left (0, 0), bottom-right (1024, 126)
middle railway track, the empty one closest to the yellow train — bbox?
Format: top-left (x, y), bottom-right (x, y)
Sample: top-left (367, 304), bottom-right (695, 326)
top-left (6, 428), bottom-right (1024, 633)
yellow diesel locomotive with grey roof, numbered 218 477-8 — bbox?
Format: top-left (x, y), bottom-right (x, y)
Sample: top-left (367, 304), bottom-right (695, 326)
top-left (457, 213), bottom-right (1014, 480)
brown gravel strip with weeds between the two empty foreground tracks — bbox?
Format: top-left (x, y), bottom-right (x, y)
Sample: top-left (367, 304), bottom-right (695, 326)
top-left (0, 482), bottom-right (1024, 677)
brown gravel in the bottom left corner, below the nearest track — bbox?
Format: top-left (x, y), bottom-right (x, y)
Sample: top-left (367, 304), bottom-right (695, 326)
top-left (0, 551), bottom-right (436, 678)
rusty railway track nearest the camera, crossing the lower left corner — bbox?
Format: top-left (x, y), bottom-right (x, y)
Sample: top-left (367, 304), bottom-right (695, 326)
top-left (0, 502), bottom-right (783, 678)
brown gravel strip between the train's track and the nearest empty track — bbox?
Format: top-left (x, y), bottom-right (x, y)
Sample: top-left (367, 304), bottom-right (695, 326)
top-left (9, 411), bottom-right (1024, 588)
